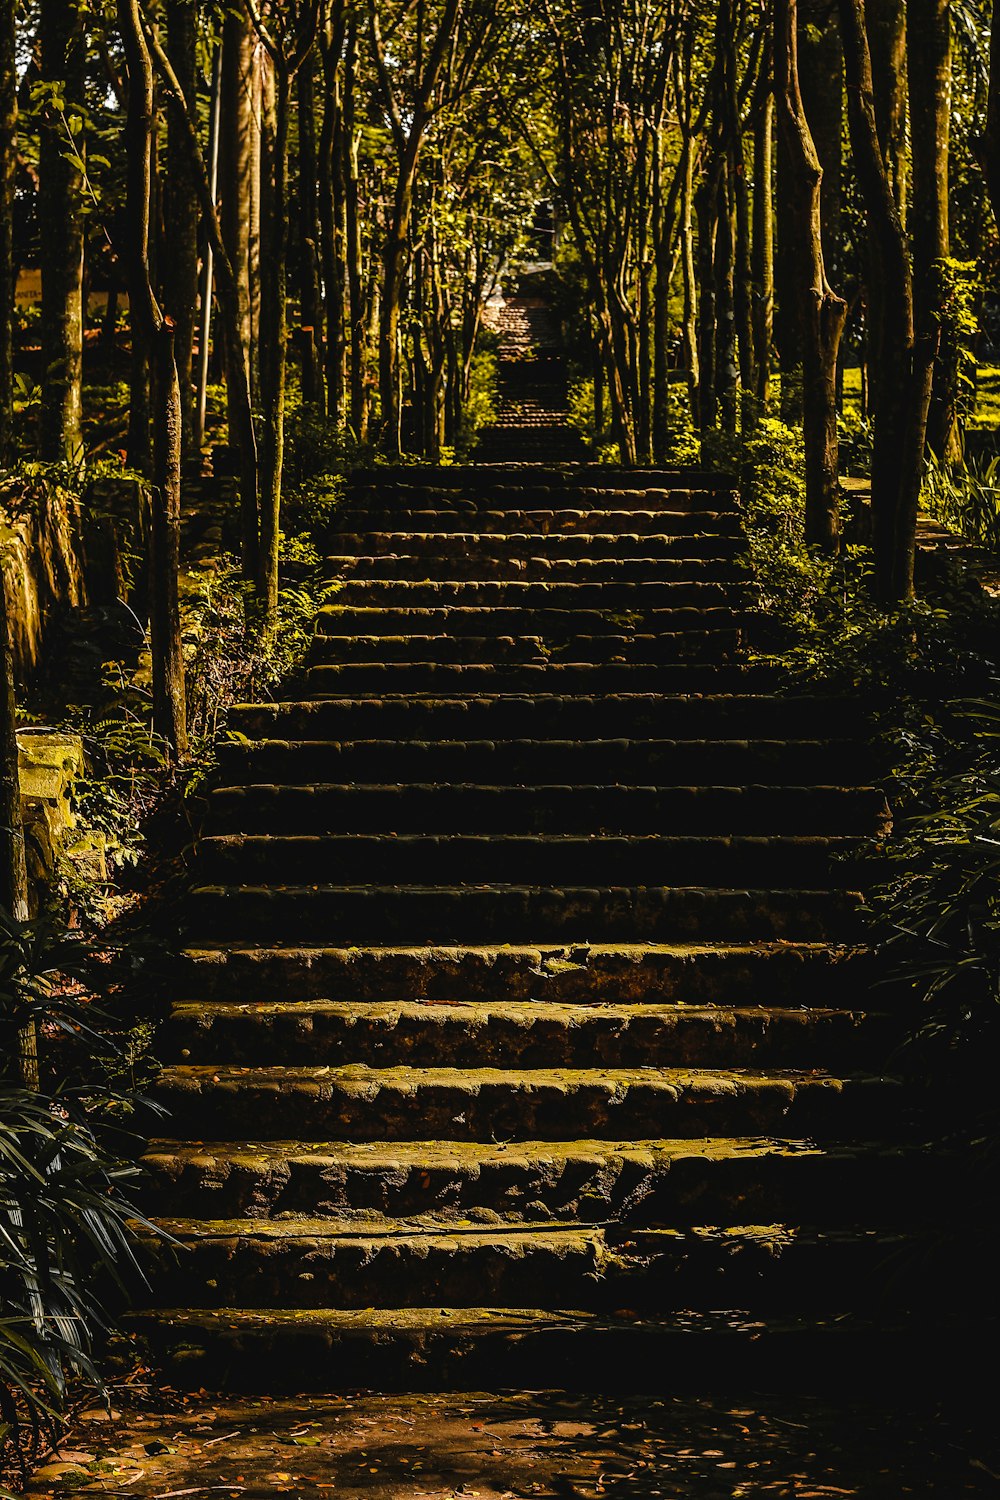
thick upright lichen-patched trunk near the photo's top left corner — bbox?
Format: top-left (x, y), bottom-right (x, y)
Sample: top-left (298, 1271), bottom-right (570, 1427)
top-left (37, 0), bottom-right (85, 464)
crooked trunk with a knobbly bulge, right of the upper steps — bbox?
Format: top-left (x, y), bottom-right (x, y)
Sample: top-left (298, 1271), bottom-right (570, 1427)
top-left (774, 0), bottom-right (847, 552)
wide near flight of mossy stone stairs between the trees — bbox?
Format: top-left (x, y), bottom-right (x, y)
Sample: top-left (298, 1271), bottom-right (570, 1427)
top-left (136, 467), bottom-right (951, 1392)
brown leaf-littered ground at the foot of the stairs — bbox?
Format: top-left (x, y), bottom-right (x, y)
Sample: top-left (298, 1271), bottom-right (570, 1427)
top-left (21, 1385), bottom-right (1000, 1500)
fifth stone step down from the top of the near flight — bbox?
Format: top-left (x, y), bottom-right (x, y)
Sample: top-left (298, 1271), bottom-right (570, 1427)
top-left (325, 548), bottom-right (745, 588)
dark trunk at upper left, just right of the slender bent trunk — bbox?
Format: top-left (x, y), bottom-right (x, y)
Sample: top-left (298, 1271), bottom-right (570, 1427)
top-left (162, 0), bottom-right (201, 453)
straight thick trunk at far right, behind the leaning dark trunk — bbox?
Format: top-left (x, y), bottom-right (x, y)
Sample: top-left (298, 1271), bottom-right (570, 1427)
top-left (907, 0), bottom-right (959, 462)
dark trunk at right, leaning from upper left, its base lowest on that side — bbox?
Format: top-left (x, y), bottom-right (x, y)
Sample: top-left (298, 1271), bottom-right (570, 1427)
top-left (840, 0), bottom-right (934, 602)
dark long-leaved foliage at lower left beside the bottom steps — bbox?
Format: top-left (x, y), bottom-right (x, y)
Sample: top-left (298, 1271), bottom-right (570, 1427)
top-left (0, 911), bottom-right (158, 1482)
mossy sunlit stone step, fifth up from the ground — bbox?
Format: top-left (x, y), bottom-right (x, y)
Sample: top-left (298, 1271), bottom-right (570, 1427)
top-left (159, 998), bottom-right (898, 1068)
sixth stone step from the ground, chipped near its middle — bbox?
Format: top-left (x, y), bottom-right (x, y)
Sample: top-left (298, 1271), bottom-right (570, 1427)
top-left (177, 942), bottom-right (873, 1007)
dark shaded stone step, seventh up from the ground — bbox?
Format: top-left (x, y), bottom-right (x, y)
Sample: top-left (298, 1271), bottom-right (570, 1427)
top-left (184, 884), bottom-right (864, 947)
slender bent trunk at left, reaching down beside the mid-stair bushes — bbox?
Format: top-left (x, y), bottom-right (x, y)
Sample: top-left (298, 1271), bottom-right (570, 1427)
top-left (118, 0), bottom-right (187, 756)
